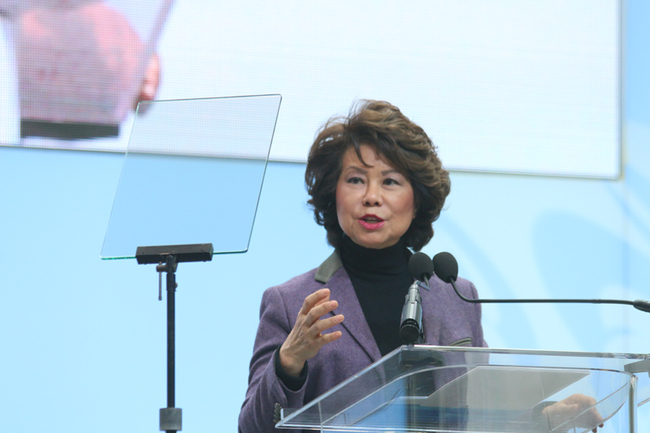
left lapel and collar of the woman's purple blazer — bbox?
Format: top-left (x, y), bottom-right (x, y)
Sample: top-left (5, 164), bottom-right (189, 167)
top-left (314, 251), bottom-right (381, 362)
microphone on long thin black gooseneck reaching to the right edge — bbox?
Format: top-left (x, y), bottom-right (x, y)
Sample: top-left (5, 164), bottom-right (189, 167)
top-left (433, 253), bottom-right (650, 313)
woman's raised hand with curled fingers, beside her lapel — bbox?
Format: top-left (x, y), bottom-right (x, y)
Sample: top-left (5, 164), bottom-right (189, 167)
top-left (280, 289), bottom-right (343, 377)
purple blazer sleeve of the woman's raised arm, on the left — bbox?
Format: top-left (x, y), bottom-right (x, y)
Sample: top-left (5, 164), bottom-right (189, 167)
top-left (239, 287), bottom-right (309, 433)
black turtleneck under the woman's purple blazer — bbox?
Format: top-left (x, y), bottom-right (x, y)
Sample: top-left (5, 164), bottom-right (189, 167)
top-left (339, 236), bottom-right (413, 356)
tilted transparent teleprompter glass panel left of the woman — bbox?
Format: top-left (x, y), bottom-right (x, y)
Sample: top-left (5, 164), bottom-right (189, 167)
top-left (101, 95), bottom-right (281, 259)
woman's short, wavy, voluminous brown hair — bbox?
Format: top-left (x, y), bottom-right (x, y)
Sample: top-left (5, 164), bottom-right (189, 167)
top-left (305, 101), bottom-right (451, 251)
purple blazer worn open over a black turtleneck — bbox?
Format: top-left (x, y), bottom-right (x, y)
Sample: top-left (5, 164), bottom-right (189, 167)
top-left (239, 252), bottom-right (480, 433)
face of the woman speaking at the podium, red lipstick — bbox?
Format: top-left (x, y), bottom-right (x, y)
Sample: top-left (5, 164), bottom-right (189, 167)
top-left (336, 144), bottom-right (415, 249)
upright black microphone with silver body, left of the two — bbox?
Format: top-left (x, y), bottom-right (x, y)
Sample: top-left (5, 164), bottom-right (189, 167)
top-left (399, 252), bottom-right (433, 344)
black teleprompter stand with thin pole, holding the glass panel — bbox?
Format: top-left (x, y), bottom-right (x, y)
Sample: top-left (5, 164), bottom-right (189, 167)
top-left (135, 244), bottom-right (214, 433)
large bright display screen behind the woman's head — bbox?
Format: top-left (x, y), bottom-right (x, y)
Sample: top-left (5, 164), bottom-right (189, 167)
top-left (0, 0), bottom-right (622, 178)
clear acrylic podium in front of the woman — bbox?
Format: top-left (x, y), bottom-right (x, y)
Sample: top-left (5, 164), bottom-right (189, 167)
top-left (276, 345), bottom-right (650, 433)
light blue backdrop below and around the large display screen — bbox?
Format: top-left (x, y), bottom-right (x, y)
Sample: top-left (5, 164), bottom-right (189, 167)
top-left (0, 0), bottom-right (650, 432)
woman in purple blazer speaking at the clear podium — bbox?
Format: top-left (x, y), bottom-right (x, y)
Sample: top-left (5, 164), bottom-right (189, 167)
top-left (239, 101), bottom-right (486, 433)
